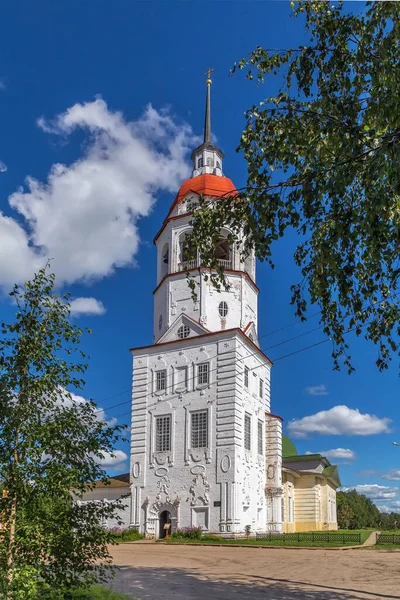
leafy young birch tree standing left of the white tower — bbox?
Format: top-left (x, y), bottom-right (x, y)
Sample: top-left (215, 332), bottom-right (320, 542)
top-left (0, 269), bottom-right (125, 600)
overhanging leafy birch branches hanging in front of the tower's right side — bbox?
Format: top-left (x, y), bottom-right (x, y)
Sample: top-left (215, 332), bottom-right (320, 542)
top-left (191, 0), bottom-right (400, 371)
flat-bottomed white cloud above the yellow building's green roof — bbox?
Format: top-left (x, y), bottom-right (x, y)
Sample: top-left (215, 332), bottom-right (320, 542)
top-left (288, 405), bottom-right (391, 438)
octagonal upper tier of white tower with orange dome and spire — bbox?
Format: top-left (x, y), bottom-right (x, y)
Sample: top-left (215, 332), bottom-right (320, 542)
top-left (154, 71), bottom-right (258, 343)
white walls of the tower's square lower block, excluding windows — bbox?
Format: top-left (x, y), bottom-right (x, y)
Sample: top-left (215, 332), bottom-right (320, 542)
top-left (131, 332), bottom-right (269, 536)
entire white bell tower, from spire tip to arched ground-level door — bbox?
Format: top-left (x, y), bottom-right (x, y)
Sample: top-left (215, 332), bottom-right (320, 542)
top-left (130, 71), bottom-right (282, 538)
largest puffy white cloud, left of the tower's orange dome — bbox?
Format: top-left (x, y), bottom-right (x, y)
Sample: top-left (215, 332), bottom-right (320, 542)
top-left (0, 98), bottom-right (197, 287)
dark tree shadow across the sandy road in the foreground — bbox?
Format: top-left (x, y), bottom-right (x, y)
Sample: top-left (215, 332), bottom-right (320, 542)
top-left (108, 567), bottom-right (400, 600)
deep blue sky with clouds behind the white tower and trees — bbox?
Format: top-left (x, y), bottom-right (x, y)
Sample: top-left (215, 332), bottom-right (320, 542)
top-left (0, 0), bottom-right (400, 507)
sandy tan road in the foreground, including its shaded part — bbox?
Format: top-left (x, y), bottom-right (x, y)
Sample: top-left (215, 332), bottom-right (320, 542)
top-left (108, 544), bottom-right (400, 600)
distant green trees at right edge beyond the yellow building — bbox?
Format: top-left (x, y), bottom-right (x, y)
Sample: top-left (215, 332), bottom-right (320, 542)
top-left (337, 490), bottom-right (400, 530)
